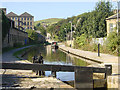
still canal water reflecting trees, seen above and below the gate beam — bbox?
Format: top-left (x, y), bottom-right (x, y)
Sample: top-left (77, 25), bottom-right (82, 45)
top-left (23, 45), bottom-right (88, 81)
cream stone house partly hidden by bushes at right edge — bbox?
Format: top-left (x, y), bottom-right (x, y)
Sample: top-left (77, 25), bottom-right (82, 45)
top-left (106, 13), bottom-right (120, 36)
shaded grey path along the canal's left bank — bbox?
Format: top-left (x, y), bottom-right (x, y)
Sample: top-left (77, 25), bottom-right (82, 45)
top-left (2, 45), bottom-right (32, 62)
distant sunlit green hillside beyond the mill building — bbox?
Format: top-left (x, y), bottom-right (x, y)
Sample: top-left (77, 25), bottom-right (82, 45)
top-left (34, 18), bottom-right (62, 26)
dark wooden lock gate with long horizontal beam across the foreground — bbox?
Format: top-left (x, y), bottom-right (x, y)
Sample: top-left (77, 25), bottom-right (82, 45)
top-left (1, 63), bottom-right (112, 90)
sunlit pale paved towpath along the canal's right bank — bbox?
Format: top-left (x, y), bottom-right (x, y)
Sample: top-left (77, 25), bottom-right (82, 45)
top-left (59, 45), bottom-right (120, 73)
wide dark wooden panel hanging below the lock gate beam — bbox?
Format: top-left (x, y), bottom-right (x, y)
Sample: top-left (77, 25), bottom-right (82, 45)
top-left (74, 68), bottom-right (93, 90)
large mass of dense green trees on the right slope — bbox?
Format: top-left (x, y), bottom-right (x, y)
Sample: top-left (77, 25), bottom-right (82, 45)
top-left (47, 1), bottom-right (113, 41)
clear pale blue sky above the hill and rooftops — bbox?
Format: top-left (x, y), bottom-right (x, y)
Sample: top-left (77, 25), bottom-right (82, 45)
top-left (0, 1), bottom-right (118, 21)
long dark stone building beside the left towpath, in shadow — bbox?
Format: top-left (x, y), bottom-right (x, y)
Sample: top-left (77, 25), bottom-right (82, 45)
top-left (2, 28), bottom-right (29, 48)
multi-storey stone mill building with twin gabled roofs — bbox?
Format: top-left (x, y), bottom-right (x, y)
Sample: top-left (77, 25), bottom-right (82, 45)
top-left (6, 12), bottom-right (34, 30)
